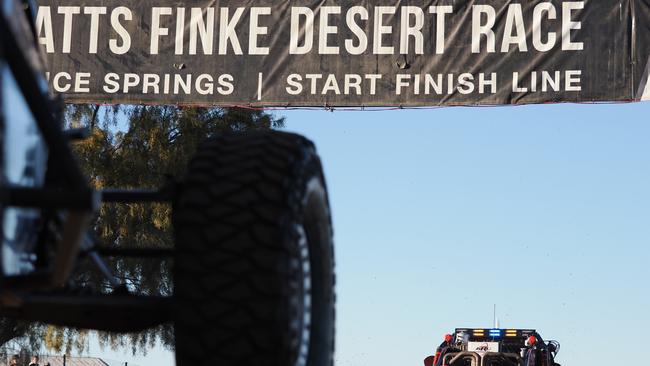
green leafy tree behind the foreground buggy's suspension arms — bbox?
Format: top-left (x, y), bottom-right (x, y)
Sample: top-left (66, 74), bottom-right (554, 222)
top-left (0, 105), bottom-right (284, 352)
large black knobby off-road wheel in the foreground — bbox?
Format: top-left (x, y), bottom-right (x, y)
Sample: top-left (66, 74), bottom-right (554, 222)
top-left (173, 131), bottom-right (335, 366)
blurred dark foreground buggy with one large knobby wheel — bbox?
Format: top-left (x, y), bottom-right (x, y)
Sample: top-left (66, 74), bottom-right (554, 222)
top-left (0, 0), bottom-right (334, 366)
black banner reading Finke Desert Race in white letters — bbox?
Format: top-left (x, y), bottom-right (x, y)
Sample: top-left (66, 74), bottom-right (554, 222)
top-left (36, 0), bottom-right (650, 107)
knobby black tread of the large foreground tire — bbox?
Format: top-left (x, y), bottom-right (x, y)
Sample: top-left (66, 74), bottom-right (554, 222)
top-left (173, 131), bottom-right (334, 366)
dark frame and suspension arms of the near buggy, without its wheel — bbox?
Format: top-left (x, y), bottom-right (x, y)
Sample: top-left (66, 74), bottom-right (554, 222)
top-left (0, 1), bottom-right (174, 332)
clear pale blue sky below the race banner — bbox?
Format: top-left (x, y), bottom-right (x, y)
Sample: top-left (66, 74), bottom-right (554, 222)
top-left (78, 103), bottom-right (650, 366)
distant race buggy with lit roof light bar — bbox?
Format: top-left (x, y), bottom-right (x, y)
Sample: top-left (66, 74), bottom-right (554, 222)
top-left (424, 328), bottom-right (560, 366)
